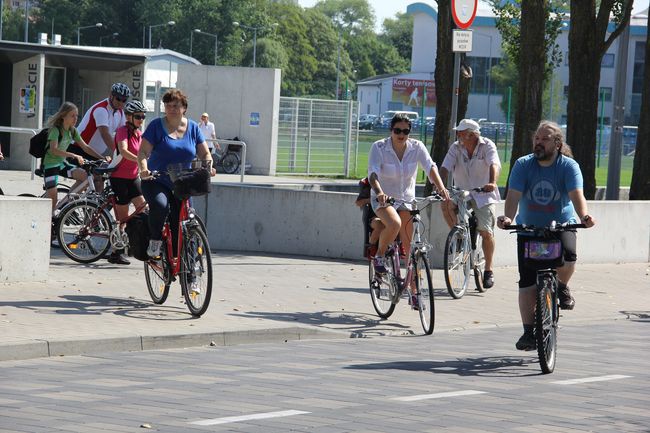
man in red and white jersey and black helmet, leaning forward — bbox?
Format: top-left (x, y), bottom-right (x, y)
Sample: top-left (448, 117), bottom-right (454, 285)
top-left (69, 83), bottom-right (131, 160)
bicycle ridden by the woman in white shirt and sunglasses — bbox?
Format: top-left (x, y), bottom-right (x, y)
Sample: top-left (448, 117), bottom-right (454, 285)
top-left (368, 195), bottom-right (442, 335)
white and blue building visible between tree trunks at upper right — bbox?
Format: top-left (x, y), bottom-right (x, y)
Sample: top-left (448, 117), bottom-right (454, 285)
top-left (357, 1), bottom-right (648, 125)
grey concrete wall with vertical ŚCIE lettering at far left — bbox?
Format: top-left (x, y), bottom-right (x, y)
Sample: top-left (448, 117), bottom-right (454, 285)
top-left (8, 54), bottom-right (45, 170)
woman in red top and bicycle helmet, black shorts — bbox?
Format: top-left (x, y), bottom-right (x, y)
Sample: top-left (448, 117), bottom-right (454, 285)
top-left (108, 100), bottom-right (147, 265)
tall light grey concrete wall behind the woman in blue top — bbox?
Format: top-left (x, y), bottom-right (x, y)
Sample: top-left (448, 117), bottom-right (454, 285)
top-left (177, 65), bottom-right (281, 175)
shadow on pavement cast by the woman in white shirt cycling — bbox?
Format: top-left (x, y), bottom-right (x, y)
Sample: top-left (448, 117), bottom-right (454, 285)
top-left (229, 311), bottom-right (413, 337)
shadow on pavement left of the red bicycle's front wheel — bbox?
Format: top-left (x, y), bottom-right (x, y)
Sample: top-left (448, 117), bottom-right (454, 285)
top-left (0, 295), bottom-right (191, 320)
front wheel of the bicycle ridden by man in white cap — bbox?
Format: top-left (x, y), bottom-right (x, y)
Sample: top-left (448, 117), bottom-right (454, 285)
top-left (444, 226), bottom-right (470, 299)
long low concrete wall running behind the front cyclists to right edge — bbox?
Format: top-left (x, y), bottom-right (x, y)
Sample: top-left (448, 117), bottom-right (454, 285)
top-left (195, 184), bottom-right (650, 267)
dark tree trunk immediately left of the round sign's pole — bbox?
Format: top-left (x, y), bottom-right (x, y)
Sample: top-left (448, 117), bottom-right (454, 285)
top-left (424, 1), bottom-right (454, 196)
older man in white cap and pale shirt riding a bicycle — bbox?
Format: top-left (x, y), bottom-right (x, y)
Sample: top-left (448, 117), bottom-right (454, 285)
top-left (440, 119), bottom-right (501, 289)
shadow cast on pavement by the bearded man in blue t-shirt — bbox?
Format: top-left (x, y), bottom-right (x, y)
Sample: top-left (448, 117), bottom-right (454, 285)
top-left (345, 356), bottom-right (542, 377)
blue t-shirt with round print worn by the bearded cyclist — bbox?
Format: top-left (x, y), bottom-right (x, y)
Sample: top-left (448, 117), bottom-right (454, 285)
top-left (508, 154), bottom-right (582, 227)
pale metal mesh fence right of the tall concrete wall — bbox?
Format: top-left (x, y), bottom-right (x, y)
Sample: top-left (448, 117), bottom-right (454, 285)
top-left (276, 97), bottom-right (359, 177)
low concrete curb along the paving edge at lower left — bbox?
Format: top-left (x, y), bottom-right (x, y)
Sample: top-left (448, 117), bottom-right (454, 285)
top-left (0, 326), bottom-right (355, 362)
